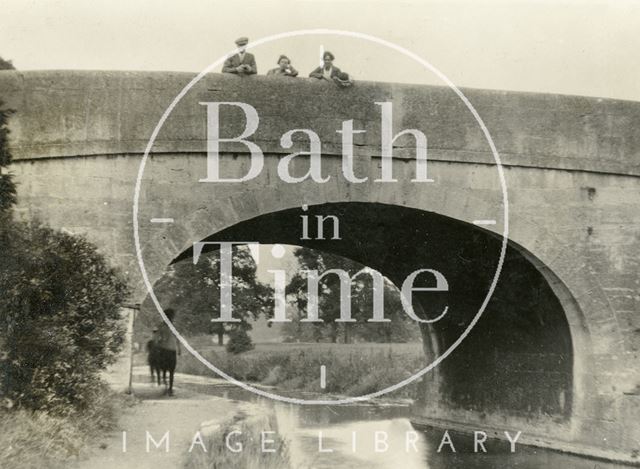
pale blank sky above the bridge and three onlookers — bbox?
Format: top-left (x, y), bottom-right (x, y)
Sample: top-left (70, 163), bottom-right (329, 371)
top-left (0, 0), bottom-right (640, 101)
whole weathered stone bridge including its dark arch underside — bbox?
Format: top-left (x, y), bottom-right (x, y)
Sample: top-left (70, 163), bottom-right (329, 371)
top-left (0, 71), bottom-right (640, 462)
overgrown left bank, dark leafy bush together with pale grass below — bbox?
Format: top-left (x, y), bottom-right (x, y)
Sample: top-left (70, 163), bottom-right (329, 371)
top-left (0, 98), bottom-right (128, 469)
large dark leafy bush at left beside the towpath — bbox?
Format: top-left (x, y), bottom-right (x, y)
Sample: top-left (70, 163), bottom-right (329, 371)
top-left (0, 220), bottom-right (128, 412)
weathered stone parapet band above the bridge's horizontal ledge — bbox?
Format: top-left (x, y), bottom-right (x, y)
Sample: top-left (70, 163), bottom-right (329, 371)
top-left (0, 71), bottom-right (640, 176)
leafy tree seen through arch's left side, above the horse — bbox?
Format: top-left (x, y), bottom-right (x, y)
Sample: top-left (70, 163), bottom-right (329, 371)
top-left (143, 246), bottom-right (273, 345)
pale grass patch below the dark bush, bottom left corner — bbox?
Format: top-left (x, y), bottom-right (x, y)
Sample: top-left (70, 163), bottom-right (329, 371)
top-left (0, 387), bottom-right (134, 469)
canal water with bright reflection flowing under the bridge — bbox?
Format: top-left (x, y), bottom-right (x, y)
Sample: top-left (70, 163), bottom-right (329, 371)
top-left (178, 378), bottom-right (629, 469)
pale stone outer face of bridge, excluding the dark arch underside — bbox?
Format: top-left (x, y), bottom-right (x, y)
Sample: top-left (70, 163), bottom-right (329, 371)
top-left (0, 72), bottom-right (640, 460)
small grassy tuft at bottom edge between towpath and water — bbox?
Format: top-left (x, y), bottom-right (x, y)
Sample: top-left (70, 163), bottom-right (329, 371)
top-left (184, 413), bottom-right (292, 469)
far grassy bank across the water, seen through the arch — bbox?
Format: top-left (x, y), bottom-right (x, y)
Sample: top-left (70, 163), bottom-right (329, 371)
top-left (179, 338), bottom-right (426, 397)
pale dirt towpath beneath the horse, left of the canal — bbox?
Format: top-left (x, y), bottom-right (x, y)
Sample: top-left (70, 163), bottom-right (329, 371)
top-left (76, 368), bottom-right (256, 469)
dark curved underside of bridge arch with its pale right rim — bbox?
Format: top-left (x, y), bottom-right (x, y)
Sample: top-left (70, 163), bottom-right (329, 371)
top-left (141, 197), bottom-right (592, 438)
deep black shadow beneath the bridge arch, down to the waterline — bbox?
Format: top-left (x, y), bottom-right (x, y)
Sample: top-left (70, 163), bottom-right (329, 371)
top-left (172, 202), bottom-right (590, 425)
